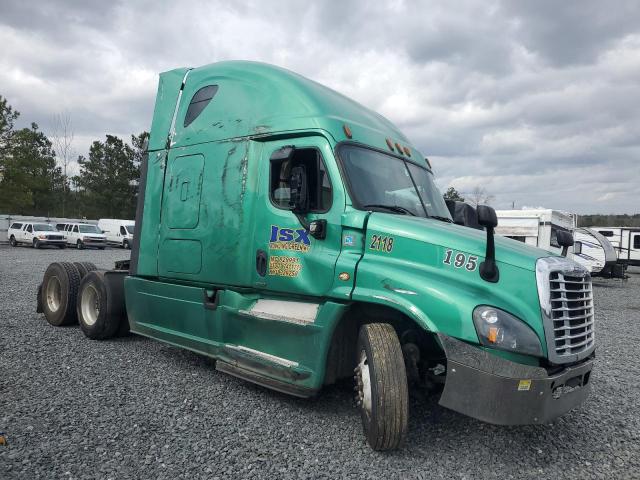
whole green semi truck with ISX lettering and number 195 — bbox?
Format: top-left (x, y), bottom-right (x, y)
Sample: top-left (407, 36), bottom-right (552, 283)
top-left (38, 62), bottom-right (595, 450)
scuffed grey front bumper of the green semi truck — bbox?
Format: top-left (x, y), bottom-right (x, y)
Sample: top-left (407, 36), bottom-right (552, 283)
top-left (438, 334), bottom-right (593, 425)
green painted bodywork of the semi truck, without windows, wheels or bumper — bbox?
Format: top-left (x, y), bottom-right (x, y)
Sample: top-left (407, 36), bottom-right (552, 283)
top-left (125, 62), bottom-right (550, 391)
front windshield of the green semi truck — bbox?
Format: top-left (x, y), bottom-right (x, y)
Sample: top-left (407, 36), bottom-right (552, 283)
top-left (339, 145), bottom-right (451, 221)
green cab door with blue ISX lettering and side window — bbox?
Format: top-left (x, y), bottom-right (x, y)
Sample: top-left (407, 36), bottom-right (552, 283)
top-left (252, 136), bottom-right (345, 297)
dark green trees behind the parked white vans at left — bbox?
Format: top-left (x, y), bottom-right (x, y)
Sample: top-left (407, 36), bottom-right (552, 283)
top-left (0, 95), bottom-right (149, 219)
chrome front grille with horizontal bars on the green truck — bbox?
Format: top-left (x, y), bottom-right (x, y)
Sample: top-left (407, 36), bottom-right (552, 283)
top-left (549, 272), bottom-right (594, 357)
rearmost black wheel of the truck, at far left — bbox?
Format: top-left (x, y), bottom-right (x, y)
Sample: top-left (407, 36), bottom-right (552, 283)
top-left (41, 262), bottom-right (80, 327)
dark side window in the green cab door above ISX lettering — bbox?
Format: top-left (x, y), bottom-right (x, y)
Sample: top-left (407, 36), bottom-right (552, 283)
top-left (270, 148), bottom-right (332, 212)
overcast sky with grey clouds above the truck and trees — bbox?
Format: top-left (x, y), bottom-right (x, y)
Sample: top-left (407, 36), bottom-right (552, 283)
top-left (0, 0), bottom-right (640, 213)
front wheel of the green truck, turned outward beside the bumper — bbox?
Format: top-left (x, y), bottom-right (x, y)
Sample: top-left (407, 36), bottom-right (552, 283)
top-left (355, 323), bottom-right (409, 450)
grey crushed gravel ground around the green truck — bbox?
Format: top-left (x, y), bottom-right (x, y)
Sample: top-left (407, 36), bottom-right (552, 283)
top-left (0, 245), bottom-right (640, 479)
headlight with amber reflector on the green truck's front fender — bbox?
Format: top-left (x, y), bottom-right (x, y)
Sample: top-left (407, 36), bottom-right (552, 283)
top-left (473, 305), bottom-right (542, 357)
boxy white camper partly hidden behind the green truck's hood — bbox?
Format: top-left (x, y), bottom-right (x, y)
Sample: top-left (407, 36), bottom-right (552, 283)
top-left (496, 208), bottom-right (576, 257)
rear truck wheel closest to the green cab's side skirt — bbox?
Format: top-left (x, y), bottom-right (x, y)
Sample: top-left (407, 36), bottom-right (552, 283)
top-left (76, 270), bottom-right (123, 340)
